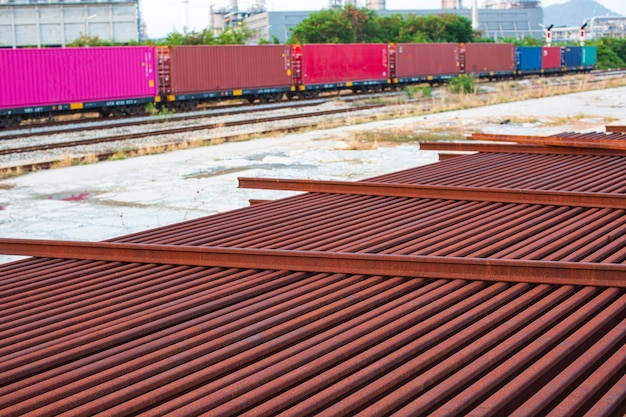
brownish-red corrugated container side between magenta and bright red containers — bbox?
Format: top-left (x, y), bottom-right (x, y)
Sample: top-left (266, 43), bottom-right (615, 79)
top-left (170, 45), bottom-right (292, 94)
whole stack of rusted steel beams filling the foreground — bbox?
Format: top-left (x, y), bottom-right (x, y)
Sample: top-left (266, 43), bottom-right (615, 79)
top-left (0, 128), bottom-right (626, 416)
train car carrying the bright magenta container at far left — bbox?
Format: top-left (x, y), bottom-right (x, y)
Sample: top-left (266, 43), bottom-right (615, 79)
top-left (0, 46), bottom-right (158, 127)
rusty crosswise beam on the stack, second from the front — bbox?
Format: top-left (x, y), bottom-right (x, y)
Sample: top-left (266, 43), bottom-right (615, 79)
top-left (239, 177), bottom-right (626, 209)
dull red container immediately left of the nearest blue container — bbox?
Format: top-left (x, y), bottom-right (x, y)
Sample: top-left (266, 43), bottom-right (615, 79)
top-left (461, 43), bottom-right (515, 77)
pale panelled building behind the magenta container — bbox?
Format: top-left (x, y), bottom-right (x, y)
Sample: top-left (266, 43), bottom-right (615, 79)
top-left (0, 0), bottom-right (143, 48)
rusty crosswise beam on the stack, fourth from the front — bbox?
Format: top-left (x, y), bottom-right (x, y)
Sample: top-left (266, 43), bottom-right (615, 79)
top-left (469, 133), bottom-right (626, 151)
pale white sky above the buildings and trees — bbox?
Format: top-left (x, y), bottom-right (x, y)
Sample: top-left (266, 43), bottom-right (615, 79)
top-left (140, 0), bottom-right (626, 38)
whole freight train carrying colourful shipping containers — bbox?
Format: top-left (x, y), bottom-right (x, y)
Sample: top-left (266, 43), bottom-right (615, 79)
top-left (0, 43), bottom-right (596, 127)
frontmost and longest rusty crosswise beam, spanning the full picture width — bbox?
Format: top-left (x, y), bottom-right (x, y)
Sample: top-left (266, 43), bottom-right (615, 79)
top-left (0, 239), bottom-right (626, 287)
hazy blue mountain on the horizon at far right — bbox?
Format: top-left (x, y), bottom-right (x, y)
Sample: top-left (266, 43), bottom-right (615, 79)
top-left (543, 0), bottom-right (620, 27)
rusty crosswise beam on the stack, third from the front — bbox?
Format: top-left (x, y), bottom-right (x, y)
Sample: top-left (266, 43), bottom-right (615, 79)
top-left (419, 142), bottom-right (626, 156)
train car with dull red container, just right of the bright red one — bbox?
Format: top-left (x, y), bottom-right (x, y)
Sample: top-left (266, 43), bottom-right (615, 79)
top-left (390, 43), bottom-right (461, 84)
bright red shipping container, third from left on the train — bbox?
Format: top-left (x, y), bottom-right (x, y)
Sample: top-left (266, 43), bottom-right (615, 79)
top-left (294, 44), bottom-right (390, 85)
